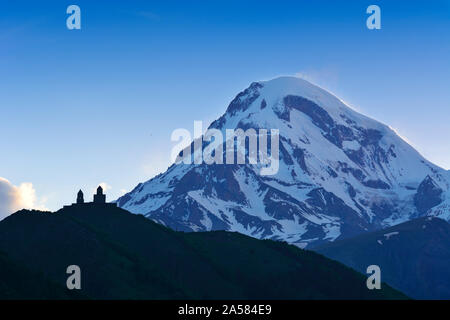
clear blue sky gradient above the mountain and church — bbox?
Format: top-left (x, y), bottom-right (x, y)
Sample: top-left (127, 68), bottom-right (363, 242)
top-left (0, 0), bottom-right (450, 210)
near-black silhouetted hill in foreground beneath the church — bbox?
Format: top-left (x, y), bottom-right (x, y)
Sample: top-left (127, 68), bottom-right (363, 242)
top-left (0, 206), bottom-right (406, 299)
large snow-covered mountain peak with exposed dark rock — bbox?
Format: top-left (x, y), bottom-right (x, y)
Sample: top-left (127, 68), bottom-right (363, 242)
top-left (117, 77), bottom-right (450, 247)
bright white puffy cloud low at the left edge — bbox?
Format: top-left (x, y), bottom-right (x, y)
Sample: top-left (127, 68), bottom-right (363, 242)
top-left (0, 177), bottom-right (45, 220)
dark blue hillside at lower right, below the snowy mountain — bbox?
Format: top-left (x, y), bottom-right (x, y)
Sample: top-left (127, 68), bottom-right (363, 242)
top-left (313, 217), bottom-right (450, 300)
